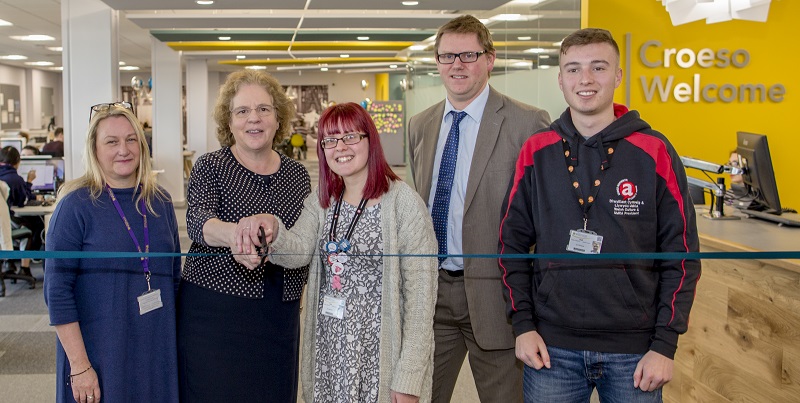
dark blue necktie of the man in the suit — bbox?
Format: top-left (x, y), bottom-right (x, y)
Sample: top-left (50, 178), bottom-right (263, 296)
top-left (431, 111), bottom-right (467, 264)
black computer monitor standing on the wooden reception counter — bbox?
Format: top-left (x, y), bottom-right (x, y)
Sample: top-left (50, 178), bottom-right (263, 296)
top-left (736, 132), bottom-right (782, 215)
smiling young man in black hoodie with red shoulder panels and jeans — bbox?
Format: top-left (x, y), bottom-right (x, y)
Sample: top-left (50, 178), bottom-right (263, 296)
top-left (499, 28), bottom-right (700, 402)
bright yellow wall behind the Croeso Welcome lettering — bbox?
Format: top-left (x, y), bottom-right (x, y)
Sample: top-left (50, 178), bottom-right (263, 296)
top-left (584, 0), bottom-right (800, 209)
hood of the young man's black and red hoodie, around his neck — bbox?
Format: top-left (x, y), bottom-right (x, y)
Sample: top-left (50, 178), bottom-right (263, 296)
top-left (550, 104), bottom-right (650, 147)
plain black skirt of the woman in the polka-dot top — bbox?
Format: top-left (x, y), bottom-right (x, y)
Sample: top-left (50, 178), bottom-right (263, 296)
top-left (178, 273), bottom-right (300, 403)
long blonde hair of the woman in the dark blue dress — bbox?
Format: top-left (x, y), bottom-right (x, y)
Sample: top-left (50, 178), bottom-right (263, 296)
top-left (58, 104), bottom-right (169, 215)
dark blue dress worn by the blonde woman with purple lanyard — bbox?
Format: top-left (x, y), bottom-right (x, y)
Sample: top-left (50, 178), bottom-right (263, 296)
top-left (44, 189), bottom-right (181, 402)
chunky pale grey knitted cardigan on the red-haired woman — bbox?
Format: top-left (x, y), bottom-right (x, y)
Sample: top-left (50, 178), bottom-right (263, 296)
top-left (270, 181), bottom-right (438, 403)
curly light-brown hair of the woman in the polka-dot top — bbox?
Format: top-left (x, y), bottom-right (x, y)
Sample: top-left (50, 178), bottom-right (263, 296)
top-left (214, 70), bottom-right (295, 147)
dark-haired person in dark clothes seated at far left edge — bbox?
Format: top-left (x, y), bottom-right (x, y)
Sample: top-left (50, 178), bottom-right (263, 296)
top-left (0, 146), bottom-right (44, 276)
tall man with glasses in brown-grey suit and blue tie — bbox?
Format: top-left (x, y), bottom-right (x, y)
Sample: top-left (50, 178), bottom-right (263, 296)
top-left (408, 15), bottom-right (550, 402)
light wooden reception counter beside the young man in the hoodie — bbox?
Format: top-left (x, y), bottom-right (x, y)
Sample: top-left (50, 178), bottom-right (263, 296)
top-left (664, 209), bottom-right (800, 402)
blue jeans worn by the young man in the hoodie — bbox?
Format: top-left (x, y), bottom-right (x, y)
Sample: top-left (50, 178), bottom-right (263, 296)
top-left (522, 346), bottom-right (662, 403)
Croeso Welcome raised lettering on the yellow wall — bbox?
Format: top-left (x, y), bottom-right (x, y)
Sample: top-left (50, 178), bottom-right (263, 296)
top-left (639, 40), bottom-right (786, 103)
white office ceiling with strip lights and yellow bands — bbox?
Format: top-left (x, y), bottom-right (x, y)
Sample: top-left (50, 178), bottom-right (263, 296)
top-left (0, 0), bottom-right (580, 71)
